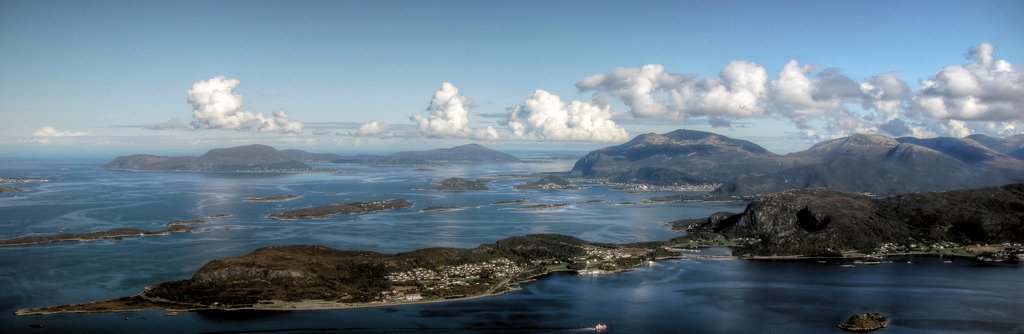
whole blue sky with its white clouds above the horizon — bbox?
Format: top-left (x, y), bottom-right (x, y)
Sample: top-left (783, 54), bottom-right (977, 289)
top-left (0, 0), bottom-right (1024, 154)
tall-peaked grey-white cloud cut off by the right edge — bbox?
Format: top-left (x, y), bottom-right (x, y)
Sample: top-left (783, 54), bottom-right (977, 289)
top-left (913, 43), bottom-right (1024, 122)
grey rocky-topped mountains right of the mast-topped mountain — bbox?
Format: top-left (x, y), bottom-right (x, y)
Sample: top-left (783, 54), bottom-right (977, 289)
top-left (715, 134), bottom-right (1024, 196)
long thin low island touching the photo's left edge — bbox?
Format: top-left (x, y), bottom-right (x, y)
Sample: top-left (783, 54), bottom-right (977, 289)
top-left (0, 220), bottom-right (206, 247)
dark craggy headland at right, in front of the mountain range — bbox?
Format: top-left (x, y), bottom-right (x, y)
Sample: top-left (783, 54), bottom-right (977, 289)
top-left (690, 183), bottom-right (1024, 255)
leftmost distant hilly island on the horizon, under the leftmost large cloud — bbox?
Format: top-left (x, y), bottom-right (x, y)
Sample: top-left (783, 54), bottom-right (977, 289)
top-left (103, 144), bottom-right (309, 172)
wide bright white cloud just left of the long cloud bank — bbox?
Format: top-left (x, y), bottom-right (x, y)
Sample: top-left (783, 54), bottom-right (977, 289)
top-left (508, 89), bottom-right (630, 141)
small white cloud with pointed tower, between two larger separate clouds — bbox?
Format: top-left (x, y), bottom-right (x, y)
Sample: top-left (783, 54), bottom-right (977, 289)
top-left (409, 82), bottom-right (501, 140)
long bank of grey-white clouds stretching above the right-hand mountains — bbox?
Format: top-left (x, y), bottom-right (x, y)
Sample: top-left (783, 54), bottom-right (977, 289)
top-left (577, 43), bottom-right (1024, 138)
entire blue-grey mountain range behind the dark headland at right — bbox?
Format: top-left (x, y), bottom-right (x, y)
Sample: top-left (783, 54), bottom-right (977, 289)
top-left (569, 130), bottom-right (1024, 196)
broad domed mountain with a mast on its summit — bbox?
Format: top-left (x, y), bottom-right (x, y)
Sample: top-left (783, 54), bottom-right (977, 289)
top-left (569, 130), bottom-right (794, 184)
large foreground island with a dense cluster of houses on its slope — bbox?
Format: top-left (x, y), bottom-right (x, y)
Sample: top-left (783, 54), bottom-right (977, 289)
top-left (16, 235), bottom-right (678, 316)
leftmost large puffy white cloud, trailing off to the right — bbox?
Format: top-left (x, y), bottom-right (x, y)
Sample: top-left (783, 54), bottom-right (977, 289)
top-left (186, 76), bottom-right (303, 133)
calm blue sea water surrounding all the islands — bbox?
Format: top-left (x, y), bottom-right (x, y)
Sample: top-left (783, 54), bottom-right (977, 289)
top-left (0, 155), bottom-right (1024, 333)
